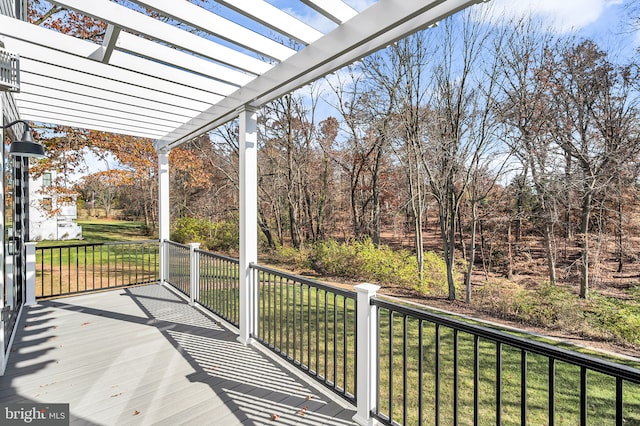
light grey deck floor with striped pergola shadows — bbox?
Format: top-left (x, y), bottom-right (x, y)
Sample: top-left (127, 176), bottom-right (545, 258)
top-left (0, 285), bottom-right (355, 426)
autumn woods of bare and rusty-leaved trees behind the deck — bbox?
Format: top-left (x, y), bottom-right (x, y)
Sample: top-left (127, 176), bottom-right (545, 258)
top-left (32, 1), bottom-right (640, 314)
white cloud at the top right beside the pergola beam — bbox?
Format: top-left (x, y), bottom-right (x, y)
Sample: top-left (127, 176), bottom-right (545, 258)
top-left (488, 0), bottom-right (623, 33)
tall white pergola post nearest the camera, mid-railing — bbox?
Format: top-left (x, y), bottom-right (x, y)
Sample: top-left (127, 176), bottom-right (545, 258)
top-left (238, 107), bottom-right (258, 345)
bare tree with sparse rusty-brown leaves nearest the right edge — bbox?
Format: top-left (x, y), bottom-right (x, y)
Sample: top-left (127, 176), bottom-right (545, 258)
top-left (547, 40), bottom-right (635, 298)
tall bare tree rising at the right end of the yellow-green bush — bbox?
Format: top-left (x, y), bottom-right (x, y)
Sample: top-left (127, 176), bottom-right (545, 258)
top-left (422, 13), bottom-right (497, 300)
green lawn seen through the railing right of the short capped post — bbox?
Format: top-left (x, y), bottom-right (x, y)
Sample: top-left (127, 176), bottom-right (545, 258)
top-left (379, 309), bottom-right (640, 425)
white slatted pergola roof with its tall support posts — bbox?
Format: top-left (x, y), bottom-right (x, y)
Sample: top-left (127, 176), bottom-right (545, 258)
top-left (0, 0), bottom-right (481, 376)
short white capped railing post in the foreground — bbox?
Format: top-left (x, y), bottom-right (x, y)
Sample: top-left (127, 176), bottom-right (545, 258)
top-left (353, 284), bottom-right (380, 426)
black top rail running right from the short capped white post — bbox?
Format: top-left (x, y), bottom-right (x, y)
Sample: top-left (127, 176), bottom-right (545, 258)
top-left (371, 297), bottom-right (640, 384)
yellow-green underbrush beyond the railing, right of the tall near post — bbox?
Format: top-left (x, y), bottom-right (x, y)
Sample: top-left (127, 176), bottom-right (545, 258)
top-left (278, 240), bottom-right (640, 348)
